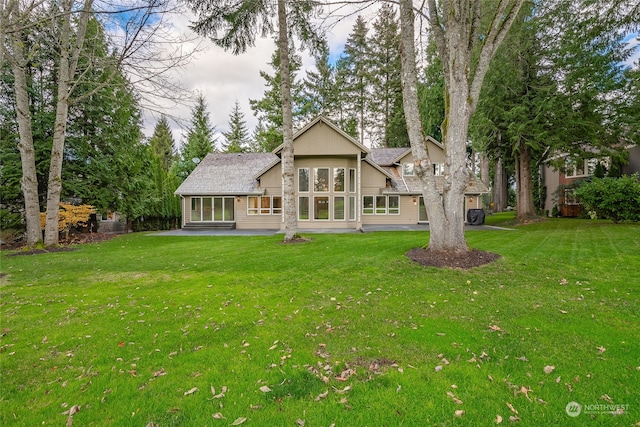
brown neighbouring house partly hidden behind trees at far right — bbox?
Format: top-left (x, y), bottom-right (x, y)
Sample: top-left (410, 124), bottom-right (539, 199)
top-left (541, 145), bottom-right (640, 217)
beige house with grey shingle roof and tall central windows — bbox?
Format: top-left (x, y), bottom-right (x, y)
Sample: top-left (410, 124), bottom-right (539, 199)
top-left (175, 117), bottom-right (487, 230)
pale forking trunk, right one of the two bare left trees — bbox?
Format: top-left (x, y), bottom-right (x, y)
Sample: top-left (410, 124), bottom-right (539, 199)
top-left (44, 0), bottom-right (93, 246)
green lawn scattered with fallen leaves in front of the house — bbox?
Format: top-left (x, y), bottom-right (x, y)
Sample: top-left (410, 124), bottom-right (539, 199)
top-left (0, 216), bottom-right (640, 426)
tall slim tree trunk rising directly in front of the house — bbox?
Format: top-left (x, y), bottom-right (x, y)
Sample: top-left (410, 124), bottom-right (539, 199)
top-left (278, 0), bottom-right (298, 242)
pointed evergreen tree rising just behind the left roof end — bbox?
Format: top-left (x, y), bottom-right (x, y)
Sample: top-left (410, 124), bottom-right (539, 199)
top-left (177, 94), bottom-right (215, 180)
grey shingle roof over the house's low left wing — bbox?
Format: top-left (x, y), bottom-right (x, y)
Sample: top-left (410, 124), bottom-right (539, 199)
top-left (175, 153), bottom-right (279, 196)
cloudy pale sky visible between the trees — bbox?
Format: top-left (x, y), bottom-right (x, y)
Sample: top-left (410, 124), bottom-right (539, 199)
top-left (143, 10), bottom-right (640, 147)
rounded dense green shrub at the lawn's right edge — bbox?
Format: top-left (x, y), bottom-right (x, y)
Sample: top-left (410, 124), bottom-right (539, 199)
top-left (575, 174), bottom-right (640, 223)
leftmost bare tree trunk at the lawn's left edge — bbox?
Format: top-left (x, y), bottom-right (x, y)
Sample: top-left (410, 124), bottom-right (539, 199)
top-left (9, 40), bottom-right (42, 246)
